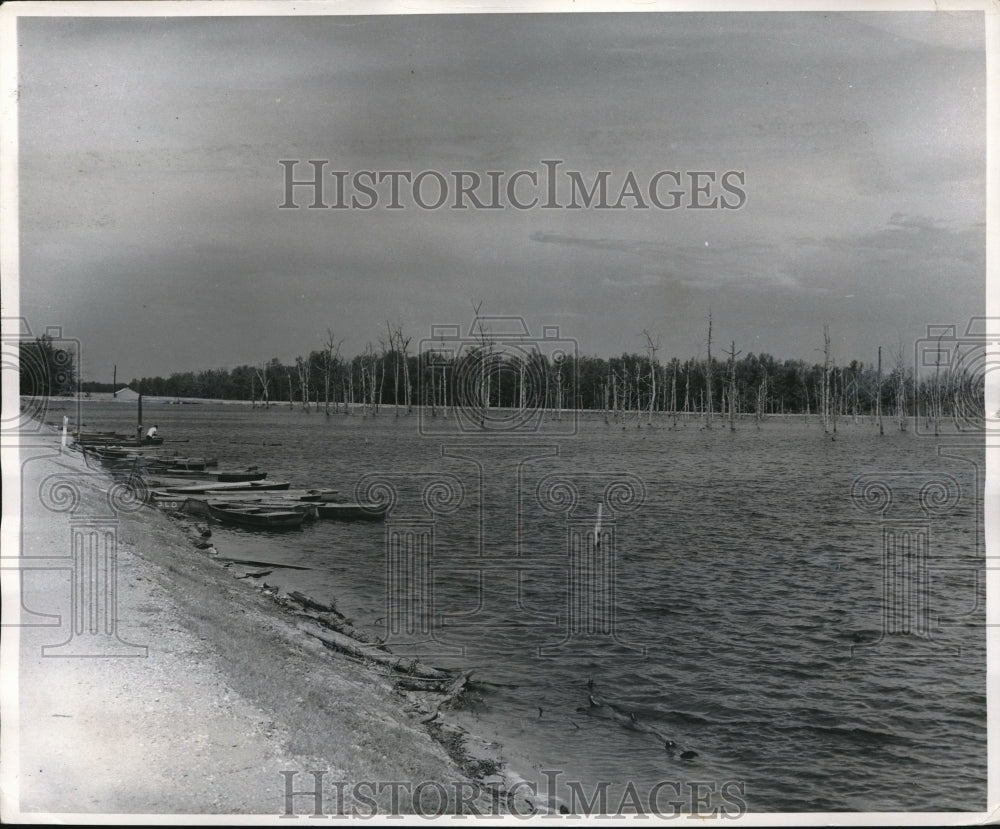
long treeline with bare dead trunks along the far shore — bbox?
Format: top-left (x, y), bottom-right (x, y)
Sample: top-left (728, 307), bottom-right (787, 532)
top-left (130, 328), bottom-right (984, 429)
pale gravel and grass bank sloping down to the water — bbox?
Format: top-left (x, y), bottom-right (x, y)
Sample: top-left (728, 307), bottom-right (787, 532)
top-left (3, 435), bottom-right (541, 822)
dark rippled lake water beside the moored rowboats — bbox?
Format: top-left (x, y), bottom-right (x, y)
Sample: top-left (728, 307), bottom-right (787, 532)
top-left (60, 403), bottom-right (986, 814)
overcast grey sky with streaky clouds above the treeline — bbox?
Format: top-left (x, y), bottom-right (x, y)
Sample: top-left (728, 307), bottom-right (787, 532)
top-left (5, 12), bottom-right (986, 381)
